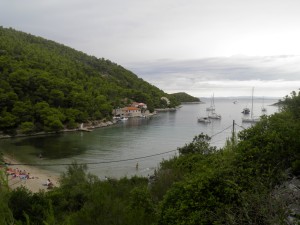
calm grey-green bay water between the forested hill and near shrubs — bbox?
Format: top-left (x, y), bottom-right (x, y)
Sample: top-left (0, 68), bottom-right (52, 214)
top-left (0, 98), bottom-right (278, 178)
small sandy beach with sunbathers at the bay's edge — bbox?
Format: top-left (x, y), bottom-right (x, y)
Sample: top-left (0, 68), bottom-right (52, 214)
top-left (3, 155), bottom-right (59, 192)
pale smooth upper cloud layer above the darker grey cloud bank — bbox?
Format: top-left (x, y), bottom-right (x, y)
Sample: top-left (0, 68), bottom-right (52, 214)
top-left (0, 0), bottom-right (300, 64)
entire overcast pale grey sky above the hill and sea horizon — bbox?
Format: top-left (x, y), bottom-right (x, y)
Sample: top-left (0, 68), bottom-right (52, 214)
top-left (0, 0), bottom-right (300, 97)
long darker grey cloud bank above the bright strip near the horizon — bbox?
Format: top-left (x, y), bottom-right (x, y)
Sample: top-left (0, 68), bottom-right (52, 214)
top-left (128, 56), bottom-right (300, 81)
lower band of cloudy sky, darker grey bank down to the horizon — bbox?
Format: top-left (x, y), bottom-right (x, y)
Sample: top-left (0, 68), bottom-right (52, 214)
top-left (123, 56), bottom-right (300, 97)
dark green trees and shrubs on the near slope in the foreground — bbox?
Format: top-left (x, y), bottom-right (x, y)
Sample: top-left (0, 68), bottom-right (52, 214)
top-left (0, 92), bottom-right (300, 225)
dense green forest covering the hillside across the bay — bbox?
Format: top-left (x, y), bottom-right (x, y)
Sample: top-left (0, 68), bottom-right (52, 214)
top-left (0, 27), bottom-right (180, 134)
